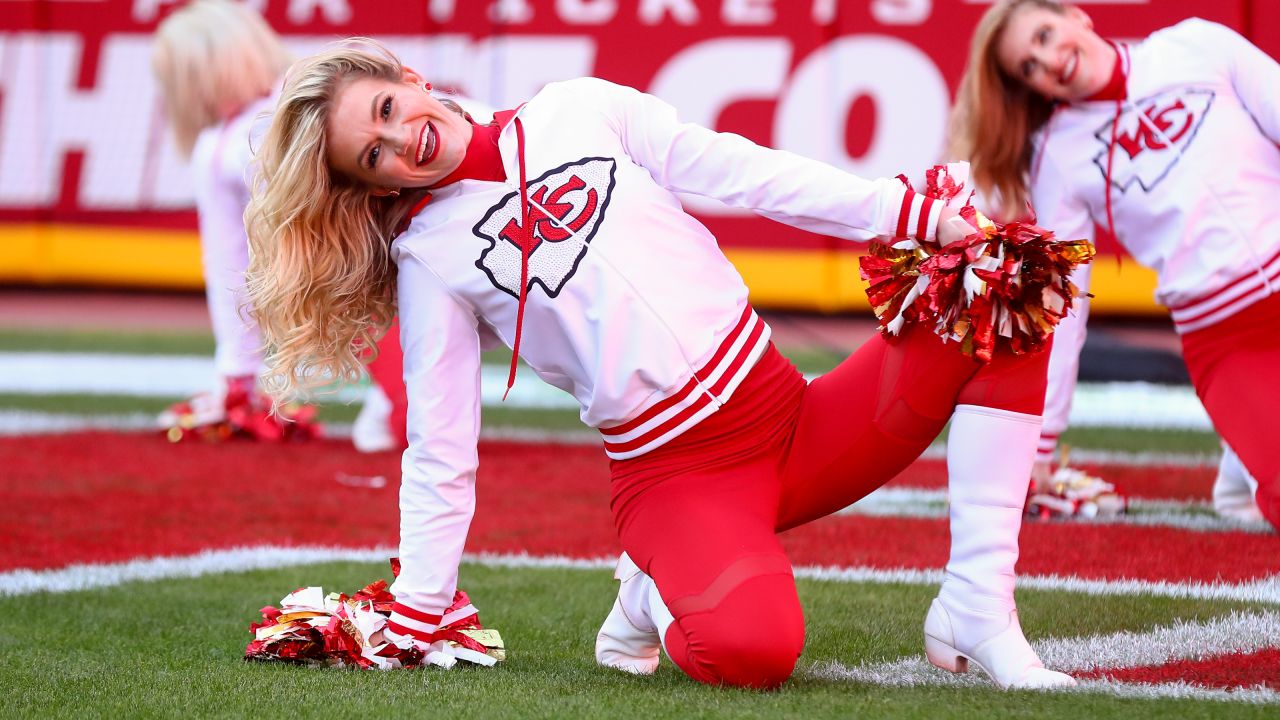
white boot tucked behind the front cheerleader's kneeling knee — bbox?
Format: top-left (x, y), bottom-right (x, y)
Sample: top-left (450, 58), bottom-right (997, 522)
top-left (595, 552), bottom-right (673, 675)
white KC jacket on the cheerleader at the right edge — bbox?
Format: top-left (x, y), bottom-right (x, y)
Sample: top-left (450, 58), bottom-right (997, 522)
top-left (1032, 19), bottom-right (1280, 459)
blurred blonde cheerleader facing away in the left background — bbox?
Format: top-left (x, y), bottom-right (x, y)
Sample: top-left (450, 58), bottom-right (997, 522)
top-left (152, 0), bottom-right (407, 451)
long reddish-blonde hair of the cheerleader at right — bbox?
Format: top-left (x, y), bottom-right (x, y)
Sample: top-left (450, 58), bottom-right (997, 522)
top-left (948, 0), bottom-right (1066, 219)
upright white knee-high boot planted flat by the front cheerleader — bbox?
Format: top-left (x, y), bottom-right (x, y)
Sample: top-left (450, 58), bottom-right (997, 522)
top-left (924, 405), bottom-right (1075, 688)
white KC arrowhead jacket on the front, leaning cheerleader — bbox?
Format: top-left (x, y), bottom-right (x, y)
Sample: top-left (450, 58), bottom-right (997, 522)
top-left (389, 78), bottom-right (941, 638)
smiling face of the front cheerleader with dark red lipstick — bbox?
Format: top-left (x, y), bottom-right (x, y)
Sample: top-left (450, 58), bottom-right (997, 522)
top-left (326, 70), bottom-right (471, 195)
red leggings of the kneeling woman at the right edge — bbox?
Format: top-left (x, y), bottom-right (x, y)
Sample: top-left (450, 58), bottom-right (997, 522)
top-left (1183, 288), bottom-right (1280, 530)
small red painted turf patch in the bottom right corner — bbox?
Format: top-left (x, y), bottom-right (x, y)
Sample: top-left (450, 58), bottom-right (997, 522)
top-left (1073, 648), bottom-right (1280, 691)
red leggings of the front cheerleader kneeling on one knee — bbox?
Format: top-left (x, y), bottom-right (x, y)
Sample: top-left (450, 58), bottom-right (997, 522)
top-left (611, 322), bottom-right (1048, 688)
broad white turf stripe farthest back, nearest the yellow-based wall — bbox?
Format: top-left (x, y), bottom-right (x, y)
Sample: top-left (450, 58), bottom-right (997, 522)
top-left (0, 352), bottom-right (1212, 430)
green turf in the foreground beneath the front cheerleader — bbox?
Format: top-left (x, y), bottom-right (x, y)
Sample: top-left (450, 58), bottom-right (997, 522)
top-left (0, 562), bottom-right (1275, 720)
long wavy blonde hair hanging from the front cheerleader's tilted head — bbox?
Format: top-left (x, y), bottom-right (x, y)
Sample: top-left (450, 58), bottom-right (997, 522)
top-left (244, 38), bottom-right (421, 400)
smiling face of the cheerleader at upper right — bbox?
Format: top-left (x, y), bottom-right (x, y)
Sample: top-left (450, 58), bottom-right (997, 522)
top-left (996, 4), bottom-right (1116, 100)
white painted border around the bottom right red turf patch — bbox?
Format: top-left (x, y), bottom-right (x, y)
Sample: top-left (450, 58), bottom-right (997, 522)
top-left (808, 611), bottom-right (1280, 703)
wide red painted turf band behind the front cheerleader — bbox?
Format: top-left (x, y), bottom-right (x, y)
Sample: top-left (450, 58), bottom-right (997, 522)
top-left (0, 433), bottom-right (1280, 583)
